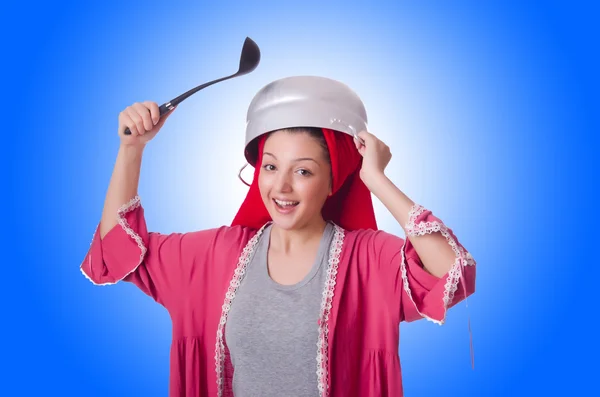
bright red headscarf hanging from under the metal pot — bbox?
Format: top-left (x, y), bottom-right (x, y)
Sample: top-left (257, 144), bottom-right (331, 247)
top-left (232, 128), bottom-right (377, 230)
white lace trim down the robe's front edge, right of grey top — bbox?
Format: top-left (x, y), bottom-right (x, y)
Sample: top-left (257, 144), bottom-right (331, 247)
top-left (317, 225), bottom-right (344, 397)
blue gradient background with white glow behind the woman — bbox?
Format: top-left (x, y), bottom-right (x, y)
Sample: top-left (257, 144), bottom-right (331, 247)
top-left (0, 1), bottom-right (600, 397)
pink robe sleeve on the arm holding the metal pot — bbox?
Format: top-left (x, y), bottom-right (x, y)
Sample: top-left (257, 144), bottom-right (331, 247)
top-left (378, 204), bottom-right (476, 325)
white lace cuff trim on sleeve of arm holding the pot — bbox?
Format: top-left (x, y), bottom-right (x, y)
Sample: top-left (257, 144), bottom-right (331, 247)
top-left (400, 204), bottom-right (475, 325)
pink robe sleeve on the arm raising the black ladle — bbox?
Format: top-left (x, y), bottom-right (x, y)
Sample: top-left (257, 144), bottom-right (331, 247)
top-left (80, 196), bottom-right (217, 309)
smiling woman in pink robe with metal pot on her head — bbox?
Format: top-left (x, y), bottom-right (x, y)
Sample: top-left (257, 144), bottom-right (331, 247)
top-left (81, 77), bottom-right (475, 397)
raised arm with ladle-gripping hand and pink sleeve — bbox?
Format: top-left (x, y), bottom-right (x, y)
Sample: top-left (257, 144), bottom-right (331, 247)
top-left (80, 102), bottom-right (198, 306)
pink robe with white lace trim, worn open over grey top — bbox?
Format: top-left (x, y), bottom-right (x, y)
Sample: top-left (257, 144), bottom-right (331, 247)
top-left (81, 196), bottom-right (475, 397)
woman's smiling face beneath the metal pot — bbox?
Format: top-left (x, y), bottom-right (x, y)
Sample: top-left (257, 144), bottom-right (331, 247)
top-left (258, 131), bottom-right (331, 229)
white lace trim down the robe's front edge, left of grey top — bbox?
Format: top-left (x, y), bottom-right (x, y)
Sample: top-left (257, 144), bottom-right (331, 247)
top-left (215, 223), bottom-right (269, 397)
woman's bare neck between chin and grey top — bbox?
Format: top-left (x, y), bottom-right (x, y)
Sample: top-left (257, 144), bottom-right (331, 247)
top-left (270, 216), bottom-right (327, 254)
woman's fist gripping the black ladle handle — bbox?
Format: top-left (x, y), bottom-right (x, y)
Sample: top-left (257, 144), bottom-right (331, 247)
top-left (119, 101), bottom-right (175, 147)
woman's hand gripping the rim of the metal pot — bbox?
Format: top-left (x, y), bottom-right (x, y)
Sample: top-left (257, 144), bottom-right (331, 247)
top-left (354, 131), bottom-right (392, 186)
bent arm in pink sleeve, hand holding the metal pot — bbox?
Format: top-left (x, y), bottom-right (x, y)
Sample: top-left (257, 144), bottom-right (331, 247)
top-left (356, 131), bottom-right (476, 324)
